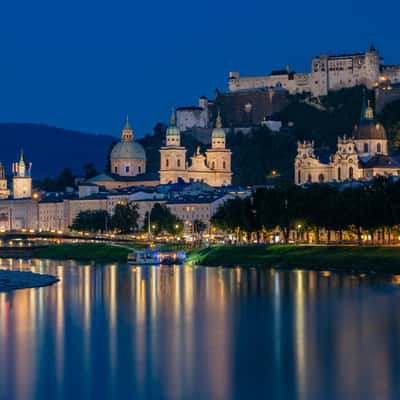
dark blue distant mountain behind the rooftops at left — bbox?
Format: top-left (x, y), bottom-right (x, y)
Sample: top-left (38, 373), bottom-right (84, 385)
top-left (0, 123), bottom-right (118, 179)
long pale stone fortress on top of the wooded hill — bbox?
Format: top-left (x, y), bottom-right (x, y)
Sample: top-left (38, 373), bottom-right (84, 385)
top-left (229, 46), bottom-right (400, 97)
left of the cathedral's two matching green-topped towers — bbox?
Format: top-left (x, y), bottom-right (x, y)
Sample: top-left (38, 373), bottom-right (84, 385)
top-left (160, 111), bottom-right (187, 184)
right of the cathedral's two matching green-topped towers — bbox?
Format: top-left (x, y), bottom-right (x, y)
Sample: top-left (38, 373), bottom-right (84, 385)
top-left (206, 113), bottom-right (232, 186)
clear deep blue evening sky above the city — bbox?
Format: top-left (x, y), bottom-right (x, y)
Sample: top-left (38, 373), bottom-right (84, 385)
top-left (0, 0), bottom-right (400, 136)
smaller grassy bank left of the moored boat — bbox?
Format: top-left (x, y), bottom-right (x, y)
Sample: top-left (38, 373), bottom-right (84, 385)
top-left (35, 243), bottom-right (135, 262)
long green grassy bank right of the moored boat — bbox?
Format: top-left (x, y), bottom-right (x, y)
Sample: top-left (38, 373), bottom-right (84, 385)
top-left (189, 245), bottom-right (400, 273)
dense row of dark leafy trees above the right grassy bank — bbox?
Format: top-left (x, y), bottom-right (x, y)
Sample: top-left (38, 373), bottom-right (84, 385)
top-left (212, 178), bottom-right (400, 242)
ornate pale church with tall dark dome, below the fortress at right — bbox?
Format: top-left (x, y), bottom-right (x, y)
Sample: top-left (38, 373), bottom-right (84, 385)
top-left (294, 96), bottom-right (400, 185)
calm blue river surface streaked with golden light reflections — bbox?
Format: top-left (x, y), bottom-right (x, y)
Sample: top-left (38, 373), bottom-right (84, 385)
top-left (0, 260), bottom-right (400, 400)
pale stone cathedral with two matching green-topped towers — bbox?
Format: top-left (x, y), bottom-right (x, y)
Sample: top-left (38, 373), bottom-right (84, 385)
top-left (160, 112), bottom-right (232, 186)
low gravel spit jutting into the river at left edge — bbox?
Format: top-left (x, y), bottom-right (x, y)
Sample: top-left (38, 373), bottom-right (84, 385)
top-left (0, 270), bottom-right (59, 292)
